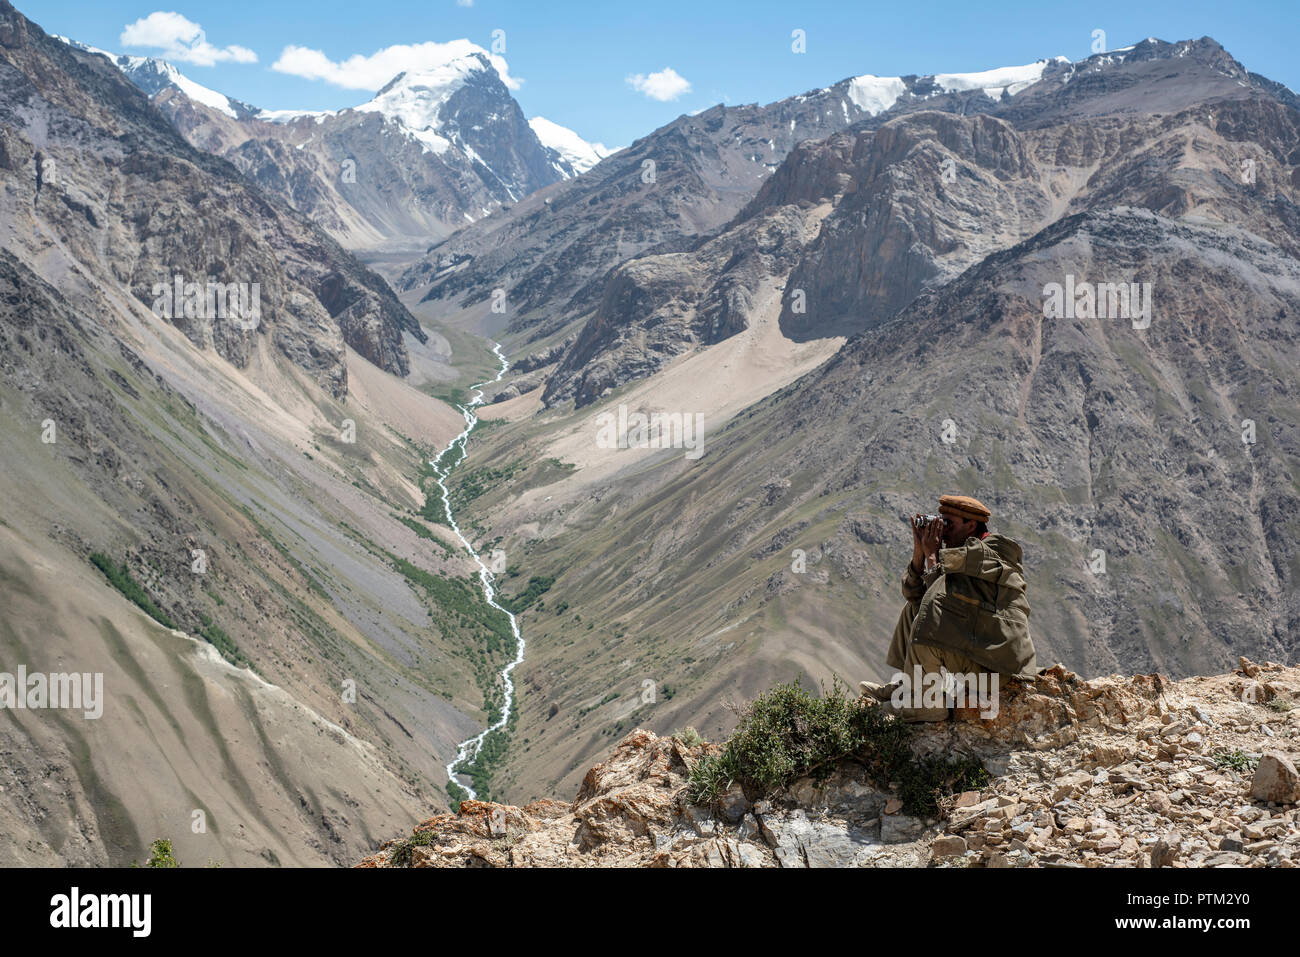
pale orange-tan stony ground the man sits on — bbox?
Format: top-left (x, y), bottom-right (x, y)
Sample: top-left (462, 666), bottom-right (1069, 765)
top-left (359, 658), bottom-right (1300, 867)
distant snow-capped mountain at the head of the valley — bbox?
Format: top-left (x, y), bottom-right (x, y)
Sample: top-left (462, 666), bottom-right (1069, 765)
top-left (60, 38), bottom-right (606, 248)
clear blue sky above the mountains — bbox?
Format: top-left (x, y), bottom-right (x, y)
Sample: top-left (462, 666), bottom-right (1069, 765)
top-left (17, 0), bottom-right (1300, 147)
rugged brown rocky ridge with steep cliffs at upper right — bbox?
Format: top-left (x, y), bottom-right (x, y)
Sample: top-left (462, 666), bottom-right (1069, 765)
top-left (543, 39), bottom-right (1300, 406)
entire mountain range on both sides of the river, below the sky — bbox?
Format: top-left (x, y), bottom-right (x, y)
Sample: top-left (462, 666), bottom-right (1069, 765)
top-left (0, 0), bottom-right (1300, 865)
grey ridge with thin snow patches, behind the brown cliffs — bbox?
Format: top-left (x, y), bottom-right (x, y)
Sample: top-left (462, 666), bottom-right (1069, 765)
top-left (398, 61), bottom-right (1065, 343)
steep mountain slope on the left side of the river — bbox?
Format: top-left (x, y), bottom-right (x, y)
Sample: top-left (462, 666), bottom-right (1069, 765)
top-left (0, 3), bottom-right (508, 866)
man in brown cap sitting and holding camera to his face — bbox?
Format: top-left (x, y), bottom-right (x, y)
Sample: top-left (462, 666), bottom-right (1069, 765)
top-left (861, 495), bottom-right (1036, 722)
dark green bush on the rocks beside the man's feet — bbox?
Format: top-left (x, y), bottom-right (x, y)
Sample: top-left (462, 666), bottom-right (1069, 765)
top-left (690, 680), bottom-right (988, 817)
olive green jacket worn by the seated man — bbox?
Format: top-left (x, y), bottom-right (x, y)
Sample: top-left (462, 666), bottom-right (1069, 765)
top-left (902, 534), bottom-right (1037, 675)
